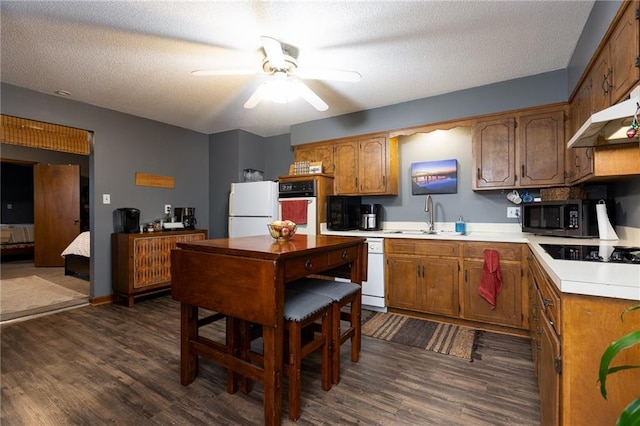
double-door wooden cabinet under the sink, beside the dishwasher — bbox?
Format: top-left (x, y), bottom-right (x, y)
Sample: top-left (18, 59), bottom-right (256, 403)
top-left (385, 239), bottom-right (459, 316)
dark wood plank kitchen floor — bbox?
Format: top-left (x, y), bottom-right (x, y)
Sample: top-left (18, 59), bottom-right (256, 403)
top-left (0, 296), bottom-right (540, 426)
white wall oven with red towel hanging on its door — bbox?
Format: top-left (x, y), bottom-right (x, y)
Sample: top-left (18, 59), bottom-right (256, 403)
top-left (278, 179), bottom-right (318, 235)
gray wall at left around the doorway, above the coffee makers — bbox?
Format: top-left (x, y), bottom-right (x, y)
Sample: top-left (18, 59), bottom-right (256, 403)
top-left (1, 84), bottom-right (209, 297)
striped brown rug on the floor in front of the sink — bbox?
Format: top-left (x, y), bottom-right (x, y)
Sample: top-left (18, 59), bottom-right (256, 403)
top-left (362, 312), bottom-right (480, 361)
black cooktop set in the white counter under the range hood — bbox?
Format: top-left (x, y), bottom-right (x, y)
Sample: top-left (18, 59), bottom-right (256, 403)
top-left (540, 244), bottom-right (640, 265)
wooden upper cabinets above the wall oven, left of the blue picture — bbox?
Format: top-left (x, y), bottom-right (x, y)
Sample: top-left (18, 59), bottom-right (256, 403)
top-left (294, 135), bottom-right (398, 195)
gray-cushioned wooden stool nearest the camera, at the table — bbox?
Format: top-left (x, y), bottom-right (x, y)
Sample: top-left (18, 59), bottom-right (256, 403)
top-left (241, 289), bottom-right (333, 420)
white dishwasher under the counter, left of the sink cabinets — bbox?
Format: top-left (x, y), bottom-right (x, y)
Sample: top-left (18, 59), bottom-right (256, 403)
top-left (362, 238), bottom-right (387, 312)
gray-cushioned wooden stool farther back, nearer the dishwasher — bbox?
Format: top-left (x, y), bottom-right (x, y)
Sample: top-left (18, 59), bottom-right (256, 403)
top-left (287, 278), bottom-right (362, 384)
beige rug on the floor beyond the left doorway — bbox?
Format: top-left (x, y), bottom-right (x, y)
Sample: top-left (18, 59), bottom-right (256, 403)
top-left (0, 275), bottom-right (89, 321)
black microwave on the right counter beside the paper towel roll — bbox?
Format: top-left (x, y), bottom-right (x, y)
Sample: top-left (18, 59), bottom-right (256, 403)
top-left (522, 200), bottom-right (615, 238)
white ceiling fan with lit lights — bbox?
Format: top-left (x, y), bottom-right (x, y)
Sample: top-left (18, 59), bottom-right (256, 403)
top-left (192, 36), bottom-right (362, 111)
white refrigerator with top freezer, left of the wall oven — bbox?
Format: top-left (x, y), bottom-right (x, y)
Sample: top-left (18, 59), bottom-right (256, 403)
top-left (229, 181), bottom-right (278, 238)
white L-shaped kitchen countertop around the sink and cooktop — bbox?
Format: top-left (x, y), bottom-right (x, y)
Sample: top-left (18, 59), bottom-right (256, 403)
top-left (321, 222), bottom-right (640, 300)
